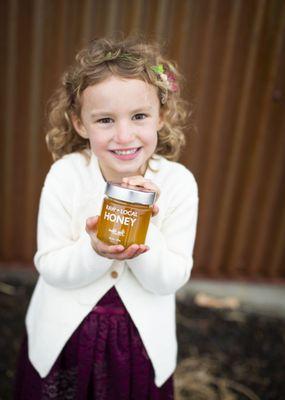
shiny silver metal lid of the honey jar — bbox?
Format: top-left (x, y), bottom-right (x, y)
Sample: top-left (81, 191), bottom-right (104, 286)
top-left (105, 182), bottom-right (156, 205)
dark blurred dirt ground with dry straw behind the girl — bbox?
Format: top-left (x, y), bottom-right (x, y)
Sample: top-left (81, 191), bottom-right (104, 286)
top-left (0, 278), bottom-right (285, 400)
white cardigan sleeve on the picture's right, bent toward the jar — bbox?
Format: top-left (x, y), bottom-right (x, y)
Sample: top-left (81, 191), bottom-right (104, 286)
top-left (127, 171), bottom-right (198, 295)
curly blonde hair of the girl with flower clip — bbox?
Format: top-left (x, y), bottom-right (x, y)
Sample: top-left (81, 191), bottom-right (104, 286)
top-left (46, 38), bottom-right (188, 160)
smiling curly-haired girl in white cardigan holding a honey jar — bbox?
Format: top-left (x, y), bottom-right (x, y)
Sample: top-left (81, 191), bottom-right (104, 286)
top-left (15, 39), bottom-right (198, 400)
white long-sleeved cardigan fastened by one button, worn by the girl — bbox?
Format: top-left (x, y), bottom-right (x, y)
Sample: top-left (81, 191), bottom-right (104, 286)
top-left (26, 153), bottom-right (198, 387)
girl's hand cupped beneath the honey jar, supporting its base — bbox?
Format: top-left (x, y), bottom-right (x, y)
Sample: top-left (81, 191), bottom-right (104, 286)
top-left (85, 215), bottom-right (149, 260)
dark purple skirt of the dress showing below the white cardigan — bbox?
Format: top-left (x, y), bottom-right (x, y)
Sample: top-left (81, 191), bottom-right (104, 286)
top-left (14, 287), bottom-right (174, 400)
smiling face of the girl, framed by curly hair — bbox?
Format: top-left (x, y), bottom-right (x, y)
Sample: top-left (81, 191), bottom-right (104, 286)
top-left (73, 76), bottom-right (163, 181)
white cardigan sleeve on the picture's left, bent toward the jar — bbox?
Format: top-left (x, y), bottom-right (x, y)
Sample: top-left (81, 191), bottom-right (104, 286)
top-left (34, 161), bottom-right (113, 289)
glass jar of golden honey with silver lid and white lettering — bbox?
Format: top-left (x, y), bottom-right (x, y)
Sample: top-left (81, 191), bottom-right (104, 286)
top-left (97, 182), bottom-right (156, 247)
